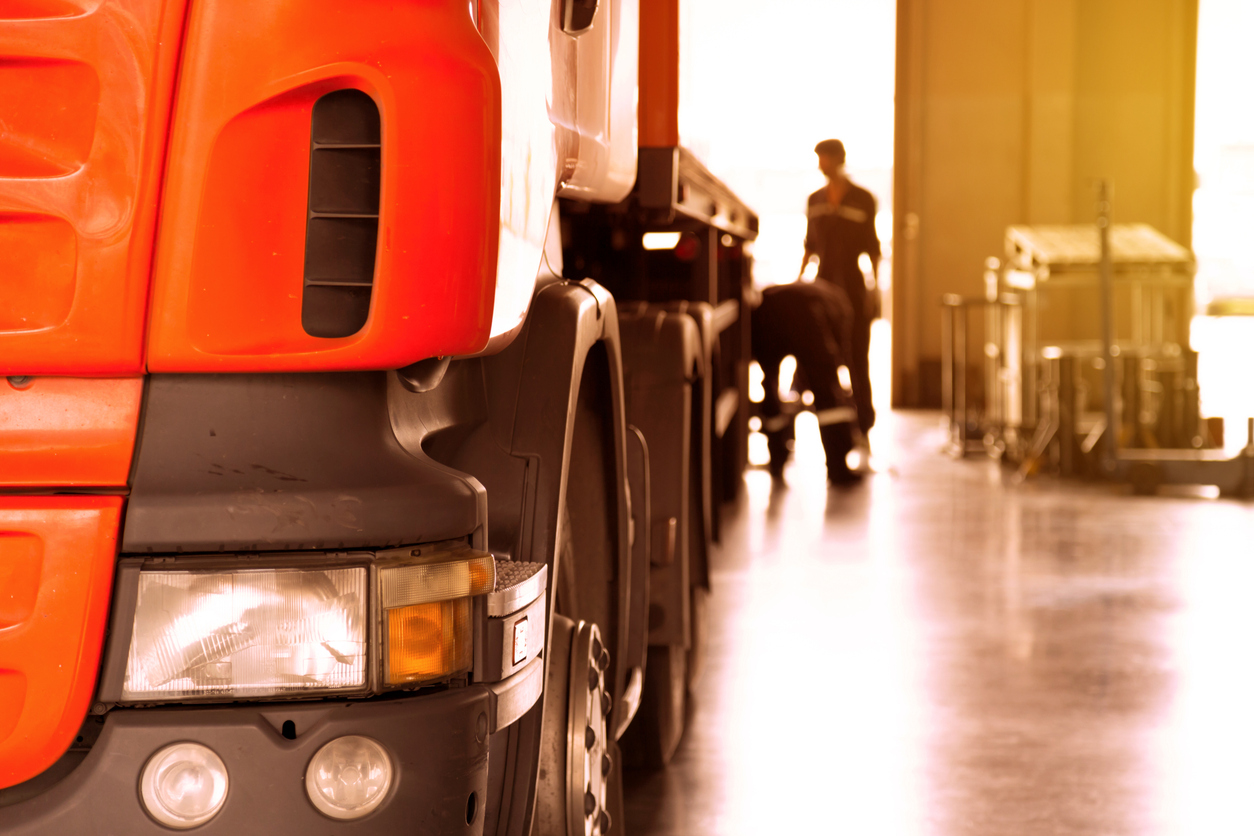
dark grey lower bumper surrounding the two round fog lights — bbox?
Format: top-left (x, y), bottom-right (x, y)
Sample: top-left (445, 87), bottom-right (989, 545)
top-left (0, 686), bottom-right (490, 836)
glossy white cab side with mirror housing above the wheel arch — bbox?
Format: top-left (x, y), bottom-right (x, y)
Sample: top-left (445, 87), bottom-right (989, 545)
top-left (478, 0), bottom-right (640, 343)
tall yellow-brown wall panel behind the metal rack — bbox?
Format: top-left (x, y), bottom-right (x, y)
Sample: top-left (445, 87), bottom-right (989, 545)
top-left (893, 0), bottom-right (1198, 406)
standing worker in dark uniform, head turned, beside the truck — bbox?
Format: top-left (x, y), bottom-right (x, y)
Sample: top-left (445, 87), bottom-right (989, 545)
top-left (801, 139), bottom-right (880, 435)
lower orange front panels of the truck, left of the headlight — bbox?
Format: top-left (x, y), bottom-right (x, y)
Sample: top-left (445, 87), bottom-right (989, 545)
top-left (0, 377), bottom-right (143, 788)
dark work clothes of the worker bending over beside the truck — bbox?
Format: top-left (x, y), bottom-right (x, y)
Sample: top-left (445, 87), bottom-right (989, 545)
top-left (750, 282), bottom-right (858, 483)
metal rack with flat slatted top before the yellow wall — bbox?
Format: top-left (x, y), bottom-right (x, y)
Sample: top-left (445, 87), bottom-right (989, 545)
top-left (999, 213), bottom-right (1203, 476)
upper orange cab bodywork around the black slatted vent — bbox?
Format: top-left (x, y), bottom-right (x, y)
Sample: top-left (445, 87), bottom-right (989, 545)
top-left (0, 0), bottom-right (500, 376)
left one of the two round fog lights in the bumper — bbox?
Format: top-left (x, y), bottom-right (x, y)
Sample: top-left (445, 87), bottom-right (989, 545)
top-left (139, 743), bottom-right (227, 830)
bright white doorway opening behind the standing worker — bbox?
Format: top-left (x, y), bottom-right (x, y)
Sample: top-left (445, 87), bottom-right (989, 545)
top-left (680, 0), bottom-right (897, 286)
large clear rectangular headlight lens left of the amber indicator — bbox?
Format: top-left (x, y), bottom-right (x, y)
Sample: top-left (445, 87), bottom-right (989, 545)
top-left (122, 567), bottom-right (367, 701)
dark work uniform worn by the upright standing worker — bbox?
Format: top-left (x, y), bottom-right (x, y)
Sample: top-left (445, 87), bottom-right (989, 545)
top-left (805, 183), bottom-right (880, 434)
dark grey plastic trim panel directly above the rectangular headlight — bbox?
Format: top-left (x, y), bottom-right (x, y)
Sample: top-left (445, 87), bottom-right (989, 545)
top-left (122, 372), bottom-right (487, 554)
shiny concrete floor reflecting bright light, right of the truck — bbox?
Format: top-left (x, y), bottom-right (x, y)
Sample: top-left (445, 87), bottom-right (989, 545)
top-left (627, 414), bottom-right (1254, 836)
